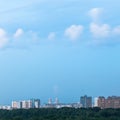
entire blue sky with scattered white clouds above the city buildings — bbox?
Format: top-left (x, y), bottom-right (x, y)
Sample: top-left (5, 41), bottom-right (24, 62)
top-left (0, 0), bottom-right (120, 104)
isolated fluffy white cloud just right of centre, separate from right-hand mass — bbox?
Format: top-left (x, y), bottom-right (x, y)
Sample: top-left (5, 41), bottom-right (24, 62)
top-left (65, 25), bottom-right (83, 40)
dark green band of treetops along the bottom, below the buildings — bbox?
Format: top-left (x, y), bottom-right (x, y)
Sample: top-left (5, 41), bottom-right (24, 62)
top-left (0, 108), bottom-right (120, 120)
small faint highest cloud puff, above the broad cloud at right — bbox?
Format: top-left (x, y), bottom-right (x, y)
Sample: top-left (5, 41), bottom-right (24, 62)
top-left (88, 8), bottom-right (103, 22)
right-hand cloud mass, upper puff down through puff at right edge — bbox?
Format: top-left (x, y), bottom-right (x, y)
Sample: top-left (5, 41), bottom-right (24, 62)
top-left (88, 8), bottom-right (120, 44)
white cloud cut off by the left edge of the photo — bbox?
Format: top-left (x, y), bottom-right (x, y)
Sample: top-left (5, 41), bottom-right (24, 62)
top-left (0, 28), bottom-right (8, 48)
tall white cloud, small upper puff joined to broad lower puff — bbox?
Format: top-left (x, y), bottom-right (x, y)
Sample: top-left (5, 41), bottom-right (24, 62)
top-left (88, 8), bottom-right (112, 38)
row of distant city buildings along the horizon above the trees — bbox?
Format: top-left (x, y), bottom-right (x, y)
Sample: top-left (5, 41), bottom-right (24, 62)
top-left (0, 95), bottom-right (120, 110)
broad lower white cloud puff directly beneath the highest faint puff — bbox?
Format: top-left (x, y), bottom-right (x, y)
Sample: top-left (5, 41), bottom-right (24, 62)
top-left (90, 23), bottom-right (111, 38)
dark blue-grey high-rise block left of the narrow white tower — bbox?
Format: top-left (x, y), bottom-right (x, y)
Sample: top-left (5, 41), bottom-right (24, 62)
top-left (80, 95), bottom-right (92, 108)
